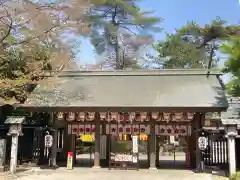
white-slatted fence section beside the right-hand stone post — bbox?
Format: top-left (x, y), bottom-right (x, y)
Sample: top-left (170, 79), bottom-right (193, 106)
top-left (202, 132), bottom-right (228, 168)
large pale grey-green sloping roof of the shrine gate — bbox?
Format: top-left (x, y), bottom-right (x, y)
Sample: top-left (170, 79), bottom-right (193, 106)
top-left (20, 70), bottom-right (228, 111)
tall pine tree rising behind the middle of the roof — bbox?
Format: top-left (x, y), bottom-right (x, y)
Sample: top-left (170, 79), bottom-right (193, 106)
top-left (90, 0), bottom-right (161, 69)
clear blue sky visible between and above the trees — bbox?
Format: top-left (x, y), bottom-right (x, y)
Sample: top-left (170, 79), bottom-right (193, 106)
top-left (77, 0), bottom-right (240, 71)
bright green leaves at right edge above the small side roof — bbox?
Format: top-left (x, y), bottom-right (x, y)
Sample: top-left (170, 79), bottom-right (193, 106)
top-left (220, 37), bottom-right (240, 96)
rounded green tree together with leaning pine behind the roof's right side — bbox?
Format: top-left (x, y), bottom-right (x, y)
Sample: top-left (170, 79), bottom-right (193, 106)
top-left (151, 18), bottom-right (240, 68)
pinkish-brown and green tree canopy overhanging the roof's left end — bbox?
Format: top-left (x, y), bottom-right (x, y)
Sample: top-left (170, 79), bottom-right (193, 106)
top-left (0, 0), bottom-right (93, 102)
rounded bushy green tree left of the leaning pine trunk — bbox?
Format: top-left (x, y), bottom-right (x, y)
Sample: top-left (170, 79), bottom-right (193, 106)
top-left (153, 34), bottom-right (207, 68)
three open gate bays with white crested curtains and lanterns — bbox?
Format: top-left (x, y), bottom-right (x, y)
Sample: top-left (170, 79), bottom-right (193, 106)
top-left (63, 112), bottom-right (194, 169)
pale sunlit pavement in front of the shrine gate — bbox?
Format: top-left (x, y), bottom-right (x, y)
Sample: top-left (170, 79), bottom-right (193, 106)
top-left (0, 168), bottom-right (227, 180)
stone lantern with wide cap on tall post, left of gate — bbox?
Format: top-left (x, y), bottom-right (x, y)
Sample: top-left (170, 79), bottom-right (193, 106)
top-left (5, 116), bottom-right (25, 174)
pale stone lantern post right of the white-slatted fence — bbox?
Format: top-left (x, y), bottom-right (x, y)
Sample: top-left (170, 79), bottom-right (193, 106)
top-left (226, 125), bottom-right (237, 176)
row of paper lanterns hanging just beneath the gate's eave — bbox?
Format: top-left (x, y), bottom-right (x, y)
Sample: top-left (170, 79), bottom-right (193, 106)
top-left (57, 112), bottom-right (194, 122)
